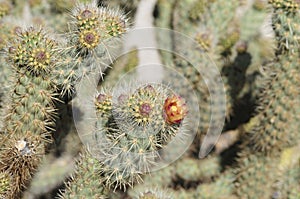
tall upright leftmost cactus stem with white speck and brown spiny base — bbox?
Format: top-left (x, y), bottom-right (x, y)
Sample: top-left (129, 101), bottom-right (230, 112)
top-left (0, 28), bottom-right (56, 198)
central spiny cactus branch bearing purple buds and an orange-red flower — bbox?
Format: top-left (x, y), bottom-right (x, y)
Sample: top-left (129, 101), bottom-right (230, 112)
top-left (96, 84), bottom-right (187, 188)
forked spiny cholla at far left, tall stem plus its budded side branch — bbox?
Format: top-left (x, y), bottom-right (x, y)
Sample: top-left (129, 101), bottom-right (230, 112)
top-left (0, 1), bottom-right (127, 198)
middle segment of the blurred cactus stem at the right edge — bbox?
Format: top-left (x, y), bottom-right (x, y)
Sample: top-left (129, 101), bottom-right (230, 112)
top-left (250, 55), bottom-right (300, 153)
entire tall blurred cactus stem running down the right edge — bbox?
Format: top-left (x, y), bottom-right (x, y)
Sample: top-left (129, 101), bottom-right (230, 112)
top-left (235, 1), bottom-right (300, 198)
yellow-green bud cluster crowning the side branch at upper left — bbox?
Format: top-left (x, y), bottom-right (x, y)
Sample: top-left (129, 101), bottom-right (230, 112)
top-left (70, 1), bottom-right (127, 55)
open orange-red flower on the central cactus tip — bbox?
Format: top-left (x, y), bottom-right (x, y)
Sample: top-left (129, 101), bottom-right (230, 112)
top-left (164, 95), bottom-right (188, 124)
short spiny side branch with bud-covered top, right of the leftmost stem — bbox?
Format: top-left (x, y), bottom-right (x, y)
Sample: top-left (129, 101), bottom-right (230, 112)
top-left (57, 1), bottom-right (128, 97)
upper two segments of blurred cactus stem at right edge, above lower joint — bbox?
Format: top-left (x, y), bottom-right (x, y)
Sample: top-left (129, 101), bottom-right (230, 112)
top-left (244, 1), bottom-right (300, 153)
